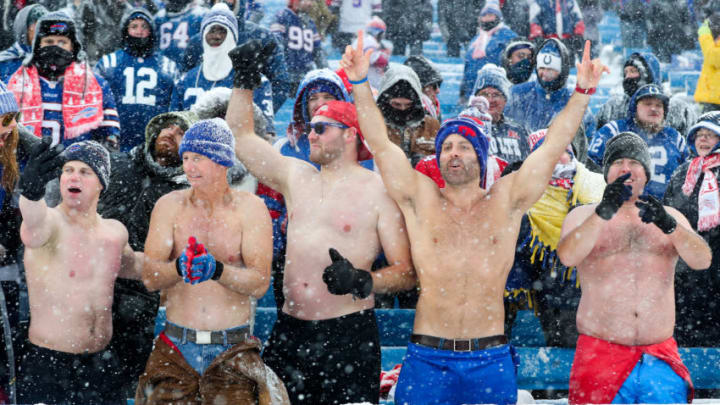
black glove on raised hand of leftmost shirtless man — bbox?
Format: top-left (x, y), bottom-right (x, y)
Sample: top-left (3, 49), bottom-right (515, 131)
top-left (19, 137), bottom-right (65, 201)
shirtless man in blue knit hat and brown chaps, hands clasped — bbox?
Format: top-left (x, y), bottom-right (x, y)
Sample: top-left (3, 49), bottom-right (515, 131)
top-left (135, 118), bottom-right (287, 404)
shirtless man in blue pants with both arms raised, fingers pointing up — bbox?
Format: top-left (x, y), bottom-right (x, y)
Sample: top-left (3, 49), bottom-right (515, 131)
top-left (340, 32), bottom-right (607, 404)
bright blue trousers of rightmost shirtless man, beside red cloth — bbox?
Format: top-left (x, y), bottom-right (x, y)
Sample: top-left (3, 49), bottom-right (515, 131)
top-left (612, 354), bottom-right (687, 404)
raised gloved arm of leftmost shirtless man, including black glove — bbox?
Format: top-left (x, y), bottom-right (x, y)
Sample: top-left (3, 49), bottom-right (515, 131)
top-left (19, 138), bottom-right (63, 248)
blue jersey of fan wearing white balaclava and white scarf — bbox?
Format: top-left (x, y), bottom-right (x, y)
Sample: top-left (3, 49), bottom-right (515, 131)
top-left (170, 65), bottom-right (275, 128)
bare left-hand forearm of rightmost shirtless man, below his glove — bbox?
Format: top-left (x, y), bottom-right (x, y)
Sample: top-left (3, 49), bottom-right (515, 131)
top-left (557, 204), bottom-right (607, 267)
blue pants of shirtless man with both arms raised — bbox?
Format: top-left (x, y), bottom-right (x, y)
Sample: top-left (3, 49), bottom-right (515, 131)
top-left (395, 343), bottom-right (517, 405)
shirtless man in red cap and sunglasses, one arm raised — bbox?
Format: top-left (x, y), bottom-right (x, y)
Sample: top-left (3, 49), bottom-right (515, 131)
top-left (227, 39), bottom-right (415, 404)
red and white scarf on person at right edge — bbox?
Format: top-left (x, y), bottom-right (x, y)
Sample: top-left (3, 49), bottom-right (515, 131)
top-left (682, 153), bottom-right (720, 231)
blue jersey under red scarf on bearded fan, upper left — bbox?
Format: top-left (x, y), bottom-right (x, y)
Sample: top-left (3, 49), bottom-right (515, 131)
top-left (28, 74), bottom-right (120, 146)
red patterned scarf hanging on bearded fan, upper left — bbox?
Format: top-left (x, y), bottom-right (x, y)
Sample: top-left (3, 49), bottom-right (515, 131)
top-left (8, 62), bottom-right (103, 139)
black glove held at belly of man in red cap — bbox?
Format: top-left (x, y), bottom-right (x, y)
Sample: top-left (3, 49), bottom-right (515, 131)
top-left (323, 248), bottom-right (372, 298)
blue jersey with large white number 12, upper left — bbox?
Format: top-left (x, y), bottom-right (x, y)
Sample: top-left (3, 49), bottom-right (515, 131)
top-left (95, 49), bottom-right (179, 152)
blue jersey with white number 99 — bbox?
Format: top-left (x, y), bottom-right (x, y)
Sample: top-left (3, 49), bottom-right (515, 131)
top-left (270, 8), bottom-right (320, 76)
